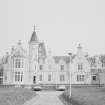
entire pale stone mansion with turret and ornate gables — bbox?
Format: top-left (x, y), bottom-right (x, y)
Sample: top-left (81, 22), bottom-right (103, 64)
top-left (0, 27), bottom-right (105, 86)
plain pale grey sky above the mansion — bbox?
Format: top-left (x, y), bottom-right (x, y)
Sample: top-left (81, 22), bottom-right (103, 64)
top-left (0, 0), bottom-right (105, 55)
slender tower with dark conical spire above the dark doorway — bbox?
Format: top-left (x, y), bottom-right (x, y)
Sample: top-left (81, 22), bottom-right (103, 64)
top-left (29, 25), bottom-right (39, 84)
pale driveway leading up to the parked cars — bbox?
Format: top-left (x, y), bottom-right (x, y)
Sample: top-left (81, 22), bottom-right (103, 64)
top-left (25, 91), bottom-right (63, 105)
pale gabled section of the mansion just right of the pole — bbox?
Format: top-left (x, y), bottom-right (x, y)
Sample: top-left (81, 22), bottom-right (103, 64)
top-left (71, 44), bottom-right (91, 84)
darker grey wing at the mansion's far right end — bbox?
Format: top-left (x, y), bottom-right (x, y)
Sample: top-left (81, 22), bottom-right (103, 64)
top-left (89, 55), bottom-right (105, 85)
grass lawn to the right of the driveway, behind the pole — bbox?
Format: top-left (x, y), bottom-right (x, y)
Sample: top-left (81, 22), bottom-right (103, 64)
top-left (63, 87), bottom-right (105, 105)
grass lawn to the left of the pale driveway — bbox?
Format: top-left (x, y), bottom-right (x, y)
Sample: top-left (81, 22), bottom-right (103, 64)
top-left (0, 87), bottom-right (36, 105)
